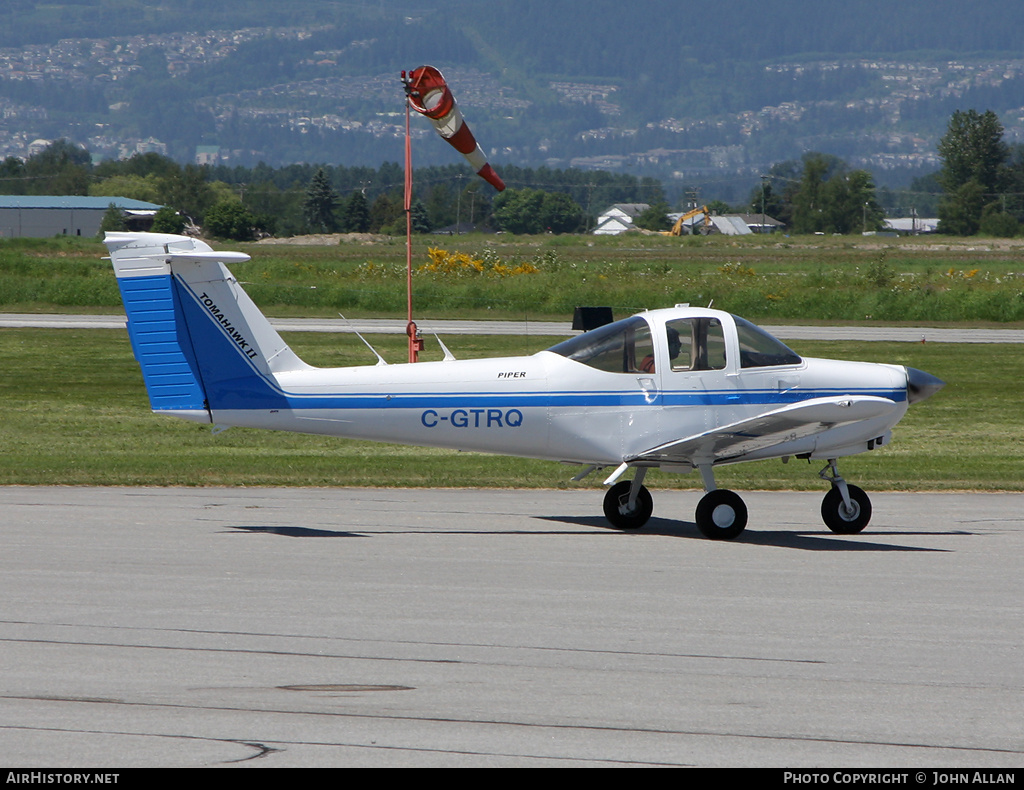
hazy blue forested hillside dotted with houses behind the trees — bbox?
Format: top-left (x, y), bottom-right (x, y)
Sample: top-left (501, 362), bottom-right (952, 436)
top-left (0, 0), bottom-right (1024, 202)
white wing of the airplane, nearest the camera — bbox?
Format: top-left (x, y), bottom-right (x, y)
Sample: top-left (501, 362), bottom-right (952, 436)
top-left (630, 396), bottom-right (897, 465)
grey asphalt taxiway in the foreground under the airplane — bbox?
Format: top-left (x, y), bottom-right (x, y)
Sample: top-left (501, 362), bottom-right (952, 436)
top-left (0, 487), bottom-right (1024, 781)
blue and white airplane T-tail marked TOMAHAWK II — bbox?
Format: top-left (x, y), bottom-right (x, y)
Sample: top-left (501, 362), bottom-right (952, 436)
top-left (104, 233), bottom-right (309, 422)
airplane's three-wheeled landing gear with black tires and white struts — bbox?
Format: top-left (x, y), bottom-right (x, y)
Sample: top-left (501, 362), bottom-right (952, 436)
top-left (604, 458), bottom-right (871, 540)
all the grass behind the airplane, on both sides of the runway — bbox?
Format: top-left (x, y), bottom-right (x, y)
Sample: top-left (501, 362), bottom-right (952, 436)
top-left (0, 236), bottom-right (1024, 491)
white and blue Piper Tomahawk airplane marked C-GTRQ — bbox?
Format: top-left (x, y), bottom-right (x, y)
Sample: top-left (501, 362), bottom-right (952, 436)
top-left (104, 233), bottom-right (944, 540)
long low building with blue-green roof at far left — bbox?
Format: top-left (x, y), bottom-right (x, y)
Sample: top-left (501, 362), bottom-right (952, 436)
top-left (0, 195), bottom-right (161, 239)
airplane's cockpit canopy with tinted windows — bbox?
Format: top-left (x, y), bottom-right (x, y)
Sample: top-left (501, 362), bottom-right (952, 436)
top-left (548, 314), bottom-right (801, 373)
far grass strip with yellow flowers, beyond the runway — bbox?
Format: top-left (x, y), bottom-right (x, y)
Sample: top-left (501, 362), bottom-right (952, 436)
top-left (6, 236), bottom-right (1024, 324)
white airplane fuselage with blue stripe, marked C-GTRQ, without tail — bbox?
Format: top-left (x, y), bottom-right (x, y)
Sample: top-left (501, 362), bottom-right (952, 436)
top-left (209, 346), bottom-right (907, 466)
